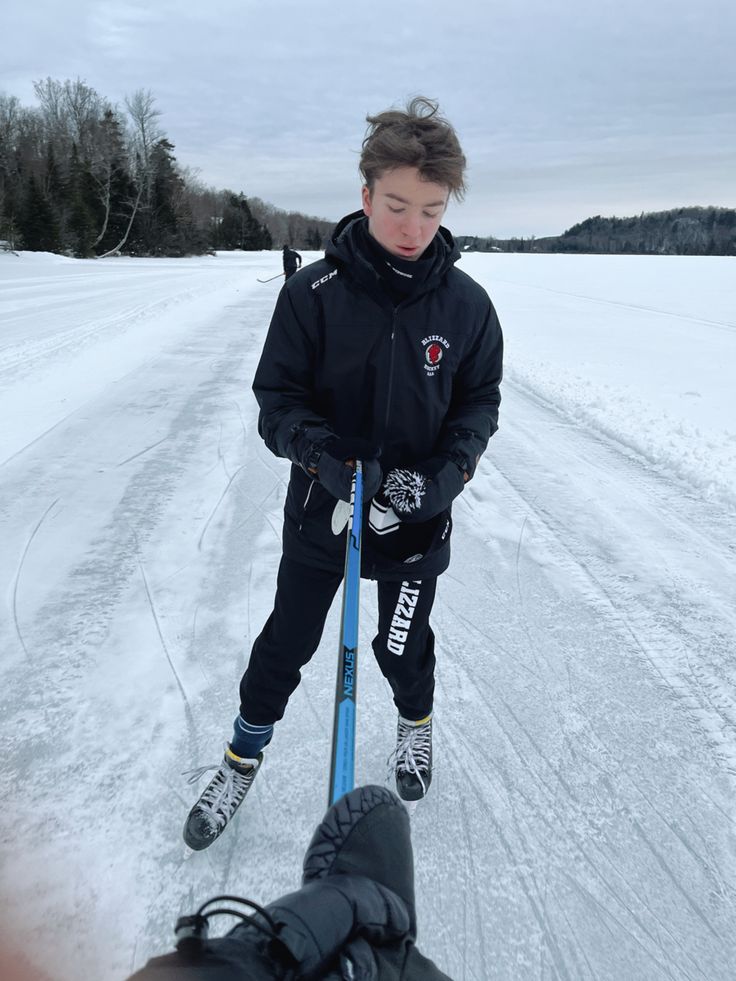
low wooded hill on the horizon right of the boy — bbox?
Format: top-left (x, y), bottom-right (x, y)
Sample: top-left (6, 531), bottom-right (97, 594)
top-left (457, 207), bottom-right (736, 255)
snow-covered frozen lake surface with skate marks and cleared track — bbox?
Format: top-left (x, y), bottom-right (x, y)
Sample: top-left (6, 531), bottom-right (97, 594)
top-left (0, 253), bottom-right (736, 981)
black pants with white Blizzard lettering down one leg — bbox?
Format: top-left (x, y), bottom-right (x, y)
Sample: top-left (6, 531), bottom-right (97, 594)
top-left (240, 557), bottom-right (437, 726)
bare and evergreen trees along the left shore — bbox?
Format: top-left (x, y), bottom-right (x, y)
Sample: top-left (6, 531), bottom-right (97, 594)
top-left (0, 78), bottom-right (332, 257)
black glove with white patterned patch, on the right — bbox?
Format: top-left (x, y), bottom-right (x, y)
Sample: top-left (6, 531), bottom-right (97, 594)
top-left (383, 457), bottom-right (465, 521)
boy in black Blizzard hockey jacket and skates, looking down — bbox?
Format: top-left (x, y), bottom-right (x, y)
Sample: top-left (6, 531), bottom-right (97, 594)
top-left (184, 98), bottom-right (503, 849)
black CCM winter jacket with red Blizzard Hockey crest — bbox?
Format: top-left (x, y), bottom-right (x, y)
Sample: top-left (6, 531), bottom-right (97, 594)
top-left (253, 212), bottom-right (503, 580)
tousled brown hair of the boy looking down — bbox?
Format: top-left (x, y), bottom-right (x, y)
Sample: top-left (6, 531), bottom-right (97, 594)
top-left (360, 96), bottom-right (466, 201)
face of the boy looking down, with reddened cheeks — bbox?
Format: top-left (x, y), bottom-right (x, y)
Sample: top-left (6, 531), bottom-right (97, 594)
top-left (363, 167), bottom-right (449, 260)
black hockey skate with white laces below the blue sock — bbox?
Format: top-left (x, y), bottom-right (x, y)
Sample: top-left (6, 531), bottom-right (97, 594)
top-left (184, 746), bottom-right (263, 851)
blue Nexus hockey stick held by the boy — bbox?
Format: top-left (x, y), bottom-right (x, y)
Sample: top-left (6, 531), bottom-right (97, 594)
top-left (328, 460), bottom-right (363, 806)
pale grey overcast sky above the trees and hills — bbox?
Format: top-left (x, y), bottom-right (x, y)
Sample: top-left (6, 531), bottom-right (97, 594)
top-left (0, 0), bottom-right (736, 237)
